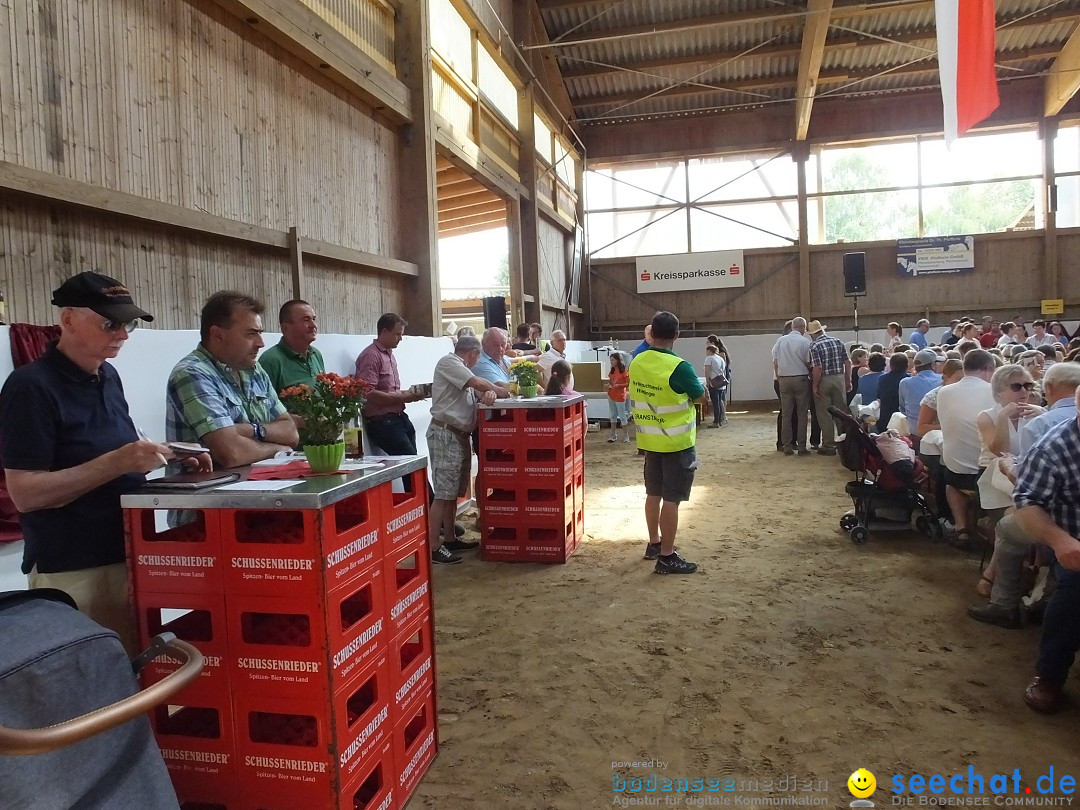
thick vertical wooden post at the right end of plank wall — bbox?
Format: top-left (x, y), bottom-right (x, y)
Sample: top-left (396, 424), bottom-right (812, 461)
top-left (395, 2), bottom-right (443, 336)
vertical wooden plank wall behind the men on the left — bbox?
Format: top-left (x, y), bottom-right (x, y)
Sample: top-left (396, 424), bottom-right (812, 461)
top-left (0, 0), bottom-right (408, 330)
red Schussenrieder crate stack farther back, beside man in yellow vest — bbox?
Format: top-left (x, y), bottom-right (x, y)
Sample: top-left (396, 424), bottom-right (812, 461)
top-left (477, 400), bottom-right (585, 563)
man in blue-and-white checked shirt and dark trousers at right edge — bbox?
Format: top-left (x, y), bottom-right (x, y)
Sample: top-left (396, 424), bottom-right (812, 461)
top-left (1013, 390), bottom-right (1080, 714)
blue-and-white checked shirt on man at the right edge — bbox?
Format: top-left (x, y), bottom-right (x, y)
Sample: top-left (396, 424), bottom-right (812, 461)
top-left (1013, 419), bottom-right (1080, 539)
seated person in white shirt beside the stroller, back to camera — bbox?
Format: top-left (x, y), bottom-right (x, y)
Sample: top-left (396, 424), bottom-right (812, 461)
top-left (937, 349), bottom-right (997, 545)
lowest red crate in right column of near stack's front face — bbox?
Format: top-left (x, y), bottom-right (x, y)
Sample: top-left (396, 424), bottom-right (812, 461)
top-left (233, 690), bottom-right (340, 810)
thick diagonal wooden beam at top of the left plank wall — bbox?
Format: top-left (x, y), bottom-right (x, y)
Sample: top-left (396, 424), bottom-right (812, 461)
top-left (214, 0), bottom-right (413, 123)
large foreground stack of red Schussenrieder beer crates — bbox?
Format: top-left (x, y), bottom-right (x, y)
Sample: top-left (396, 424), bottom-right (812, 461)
top-left (126, 470), bottom-right (437, 810)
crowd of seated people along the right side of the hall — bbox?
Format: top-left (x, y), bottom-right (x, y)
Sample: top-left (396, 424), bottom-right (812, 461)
top-left (833, 318), bottom-right (1080, 713)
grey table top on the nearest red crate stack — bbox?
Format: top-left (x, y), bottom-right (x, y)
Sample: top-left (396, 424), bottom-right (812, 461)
top-left (120, 456), bottom-right (428, 510)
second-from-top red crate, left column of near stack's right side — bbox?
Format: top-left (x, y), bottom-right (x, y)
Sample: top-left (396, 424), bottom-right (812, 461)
top-left (326, 561), bottom-right (392, 689)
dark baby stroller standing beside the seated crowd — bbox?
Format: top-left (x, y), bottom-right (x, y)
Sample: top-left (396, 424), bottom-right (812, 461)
top-left (828, 407), bottom-right (943, 545)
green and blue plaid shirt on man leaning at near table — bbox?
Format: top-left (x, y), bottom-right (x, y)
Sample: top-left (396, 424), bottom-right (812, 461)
top-left (165, 343), bottom-right (285, 442)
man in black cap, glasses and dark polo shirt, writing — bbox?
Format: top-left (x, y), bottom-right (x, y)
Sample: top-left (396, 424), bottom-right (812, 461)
top-left (0, 272), bottom-right (210, 651)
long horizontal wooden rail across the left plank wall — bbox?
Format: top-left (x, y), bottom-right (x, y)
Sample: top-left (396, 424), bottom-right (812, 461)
top-left (0, 161), bottom-right (417, 275)
